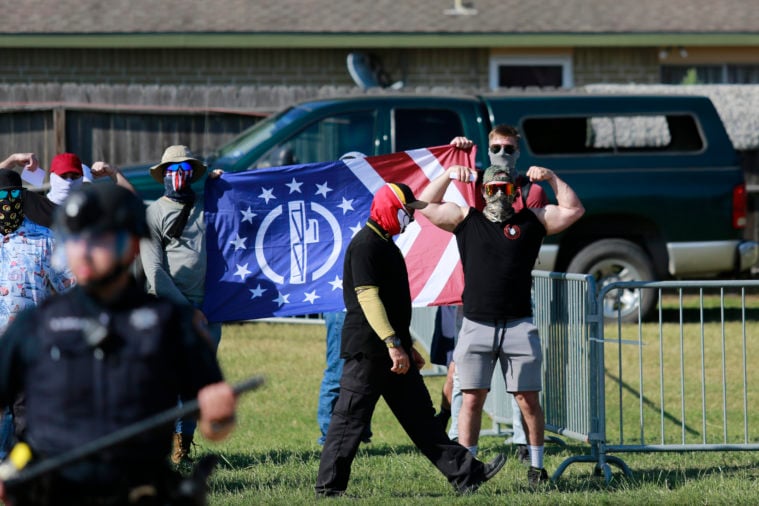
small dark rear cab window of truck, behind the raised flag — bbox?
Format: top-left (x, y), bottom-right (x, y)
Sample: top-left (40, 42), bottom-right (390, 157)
top-left (393, 109), bottom-right (464, 152)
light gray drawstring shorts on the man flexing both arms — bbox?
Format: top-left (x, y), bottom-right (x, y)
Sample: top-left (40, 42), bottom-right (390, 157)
top-left (453, 318), bottom-right (543, 392)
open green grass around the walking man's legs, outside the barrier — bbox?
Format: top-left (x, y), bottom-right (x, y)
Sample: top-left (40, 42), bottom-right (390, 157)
top-left (191, 323), bottom-right (759, 506)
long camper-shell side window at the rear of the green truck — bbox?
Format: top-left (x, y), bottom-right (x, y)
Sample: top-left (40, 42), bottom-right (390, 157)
top-left (522, 114), bottom-right (704, 155)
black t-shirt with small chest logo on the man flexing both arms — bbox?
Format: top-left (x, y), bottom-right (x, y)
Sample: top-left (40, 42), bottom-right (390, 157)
top-left (453, 208), bottom-right (546, 322)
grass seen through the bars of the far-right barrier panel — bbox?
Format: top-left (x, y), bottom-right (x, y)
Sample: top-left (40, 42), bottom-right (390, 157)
top-left (604, 295), bottom-right (759, 444)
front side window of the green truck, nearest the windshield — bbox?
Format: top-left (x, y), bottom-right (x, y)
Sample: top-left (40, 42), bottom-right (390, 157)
top-left (251, 111), bottom-right (375, 168)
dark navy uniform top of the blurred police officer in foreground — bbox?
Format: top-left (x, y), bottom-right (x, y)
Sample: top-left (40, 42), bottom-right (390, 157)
top-left (0, 282), bottom-right (222, 486)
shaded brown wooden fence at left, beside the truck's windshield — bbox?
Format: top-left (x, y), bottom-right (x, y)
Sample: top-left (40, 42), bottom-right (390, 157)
top-left (0, 103), bottom-right (265, 168)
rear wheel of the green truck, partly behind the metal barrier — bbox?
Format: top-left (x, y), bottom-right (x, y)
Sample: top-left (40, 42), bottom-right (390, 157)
top-left (567, 239), bottom-right (657, 322)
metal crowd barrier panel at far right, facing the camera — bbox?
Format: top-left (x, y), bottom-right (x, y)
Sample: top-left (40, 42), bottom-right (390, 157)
top-left (592, 280), bottom-right (759, 480)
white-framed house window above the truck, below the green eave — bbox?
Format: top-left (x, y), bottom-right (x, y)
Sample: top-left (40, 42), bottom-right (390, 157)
top-left (490, 56), bottom-right (573, 89)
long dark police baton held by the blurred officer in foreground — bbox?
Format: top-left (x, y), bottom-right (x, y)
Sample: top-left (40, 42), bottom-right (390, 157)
top-left (5, 376), bottom-right (264, 490)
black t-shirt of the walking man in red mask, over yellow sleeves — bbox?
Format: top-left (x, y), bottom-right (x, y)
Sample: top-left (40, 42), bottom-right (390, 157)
top-left (341, 226), bottom-right (411, 358)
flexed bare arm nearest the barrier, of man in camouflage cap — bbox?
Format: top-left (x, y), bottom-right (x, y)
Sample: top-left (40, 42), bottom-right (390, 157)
top-left (527, 165), bottom-right (585, 235)
